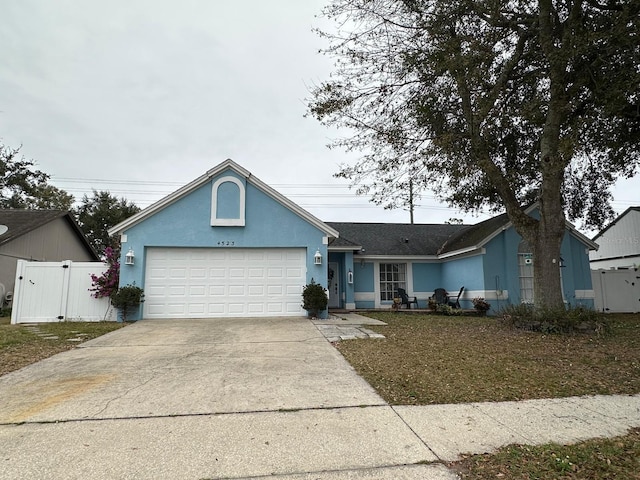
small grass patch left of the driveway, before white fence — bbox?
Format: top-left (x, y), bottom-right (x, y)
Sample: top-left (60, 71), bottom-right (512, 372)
top-left (0, 317), bottom-right (126, 376)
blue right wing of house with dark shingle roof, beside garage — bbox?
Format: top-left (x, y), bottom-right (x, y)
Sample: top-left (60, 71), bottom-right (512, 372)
top-left (328, 206), bottom-right (597, 312)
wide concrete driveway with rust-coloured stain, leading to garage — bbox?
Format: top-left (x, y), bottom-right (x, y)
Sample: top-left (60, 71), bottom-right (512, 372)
top-left (0, 318), bottom-right (455, 480)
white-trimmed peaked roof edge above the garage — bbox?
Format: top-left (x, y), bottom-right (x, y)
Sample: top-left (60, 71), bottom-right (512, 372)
top-left (109, 159), bottom-right (338, 237)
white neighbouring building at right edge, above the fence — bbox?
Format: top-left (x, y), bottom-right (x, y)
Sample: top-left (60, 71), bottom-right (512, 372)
top-left (589, 207), bottom-right (640, 270)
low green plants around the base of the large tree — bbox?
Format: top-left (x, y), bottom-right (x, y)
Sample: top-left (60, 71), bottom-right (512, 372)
top-left (501, 304), bottom-right (609, 333)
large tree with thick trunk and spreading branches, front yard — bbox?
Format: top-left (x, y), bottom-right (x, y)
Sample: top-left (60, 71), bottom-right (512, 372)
top-left (309, 0), bottom-right (640, 305)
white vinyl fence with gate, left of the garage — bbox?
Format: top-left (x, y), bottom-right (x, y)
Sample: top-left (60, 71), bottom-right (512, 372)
top-left (11, 260), bottom-right (115, 323)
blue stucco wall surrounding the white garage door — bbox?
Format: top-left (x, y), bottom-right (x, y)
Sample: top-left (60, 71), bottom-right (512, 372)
top-left (120, 171), bottom-right (328, 318)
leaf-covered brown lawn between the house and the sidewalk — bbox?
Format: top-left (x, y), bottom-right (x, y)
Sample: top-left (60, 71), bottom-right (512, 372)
top-left (337, 313), bottom-right (640, 405)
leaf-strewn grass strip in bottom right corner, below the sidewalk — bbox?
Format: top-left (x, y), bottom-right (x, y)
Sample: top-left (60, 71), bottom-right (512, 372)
top-left (449, 429), bottom-right (640, 480)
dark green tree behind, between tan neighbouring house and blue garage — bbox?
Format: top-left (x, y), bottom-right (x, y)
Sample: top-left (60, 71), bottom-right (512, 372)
top-left (75, 190), bottom-right (140, 252)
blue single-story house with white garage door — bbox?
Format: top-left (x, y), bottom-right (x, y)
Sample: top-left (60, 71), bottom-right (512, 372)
top-left (109, 160), bottom-right (596, 318)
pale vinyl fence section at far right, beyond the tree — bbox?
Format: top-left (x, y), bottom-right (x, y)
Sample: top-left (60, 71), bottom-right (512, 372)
top-left (591, 269), bottom-right (640, 313)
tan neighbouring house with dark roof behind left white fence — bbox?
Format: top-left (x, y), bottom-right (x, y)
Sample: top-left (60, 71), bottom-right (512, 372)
top-left (0, 210), bottom-right (99, 300)
